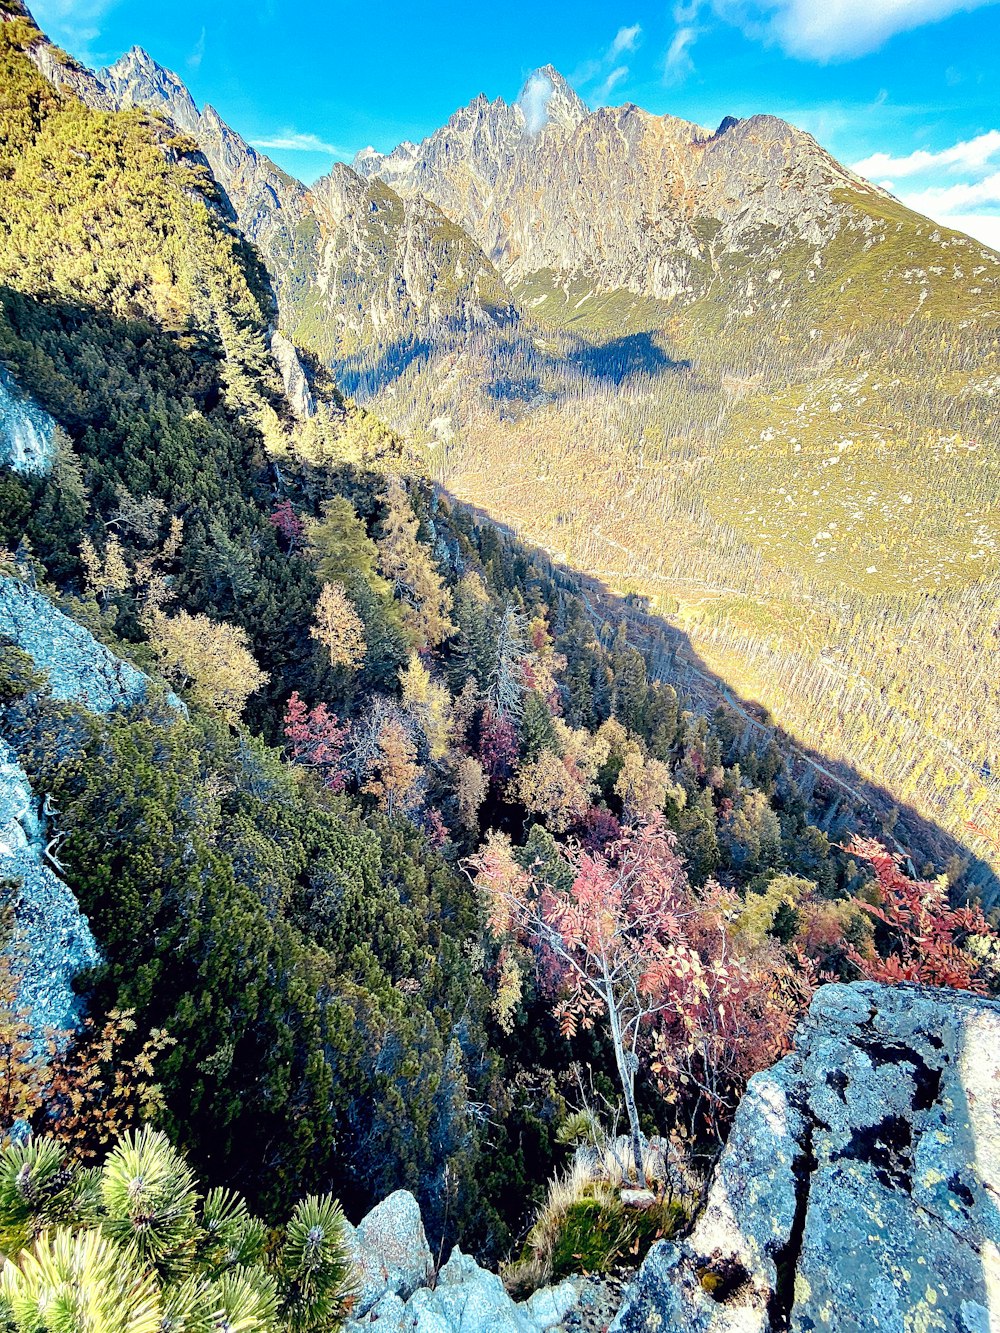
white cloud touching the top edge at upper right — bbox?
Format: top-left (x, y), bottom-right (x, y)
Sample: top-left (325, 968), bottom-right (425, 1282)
top-left (712, 0), bottom-right (1000, 61)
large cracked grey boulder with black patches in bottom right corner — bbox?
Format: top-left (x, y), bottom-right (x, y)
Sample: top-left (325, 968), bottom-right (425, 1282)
top-left (612, 982), bottom-right (1000, 1333)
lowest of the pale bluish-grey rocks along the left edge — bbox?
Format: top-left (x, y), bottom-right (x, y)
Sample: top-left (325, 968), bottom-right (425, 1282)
top-left (0, 740), bottom-right (100, 1050)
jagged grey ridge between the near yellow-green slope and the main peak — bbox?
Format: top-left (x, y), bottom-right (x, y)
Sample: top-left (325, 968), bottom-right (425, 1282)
top-left (91, 47), bottom-right (513, 363)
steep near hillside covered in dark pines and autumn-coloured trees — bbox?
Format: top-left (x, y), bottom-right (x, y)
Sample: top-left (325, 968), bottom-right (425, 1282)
top-left (0, 0), bottom-right (995, 1311)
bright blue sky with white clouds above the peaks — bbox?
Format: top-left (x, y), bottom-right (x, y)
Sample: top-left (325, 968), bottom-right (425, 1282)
top-left (28, 0), bottom-right (1000, 248)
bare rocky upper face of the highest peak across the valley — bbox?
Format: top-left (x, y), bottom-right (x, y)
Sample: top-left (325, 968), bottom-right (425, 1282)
top-left (355, 67), bottom-right (876, 299)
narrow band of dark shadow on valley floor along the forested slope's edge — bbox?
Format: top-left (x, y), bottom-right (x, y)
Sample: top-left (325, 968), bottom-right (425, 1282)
top-left (439, 488), bottom-right (1000, 910)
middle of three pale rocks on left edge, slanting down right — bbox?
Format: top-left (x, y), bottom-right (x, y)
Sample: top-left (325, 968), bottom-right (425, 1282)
top-left (0, 577), bottom-right (176, 713)
